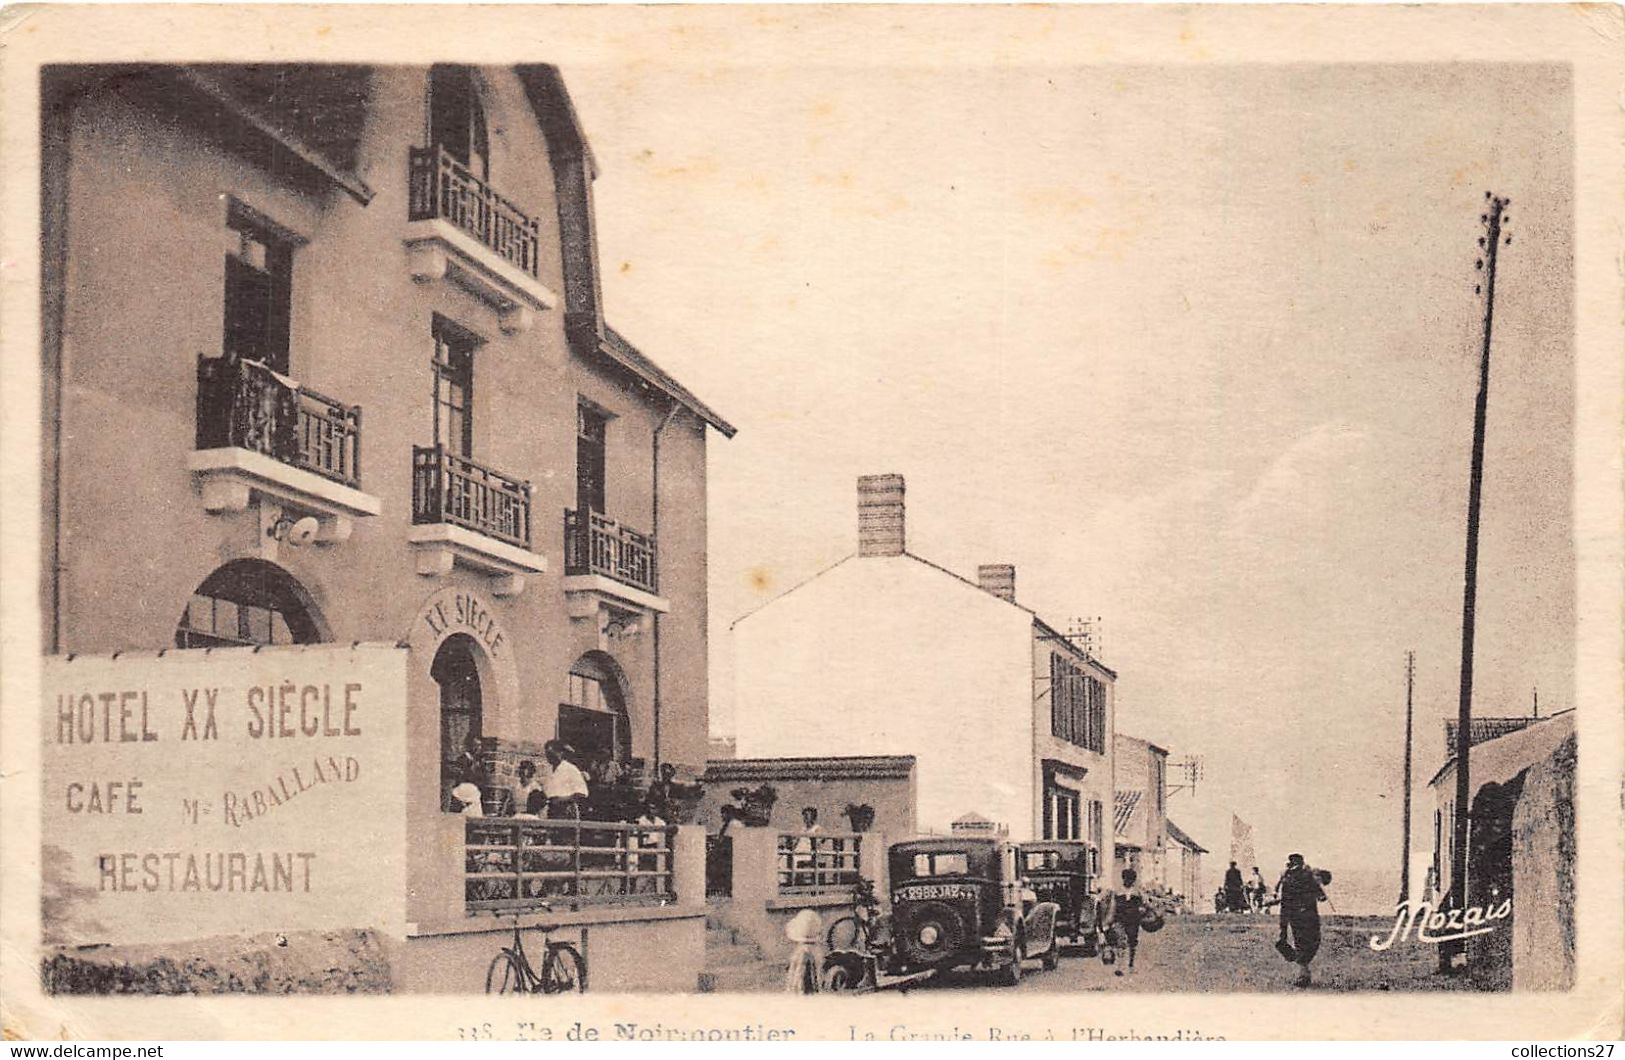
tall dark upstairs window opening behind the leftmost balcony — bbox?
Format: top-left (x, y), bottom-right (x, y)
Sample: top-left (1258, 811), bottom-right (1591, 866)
top-left (224, 203), bottom-right (294, 376)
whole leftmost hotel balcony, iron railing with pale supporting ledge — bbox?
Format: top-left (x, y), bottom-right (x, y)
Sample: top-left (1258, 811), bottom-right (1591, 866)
top-left (187, 358), bottom-right (380, 543)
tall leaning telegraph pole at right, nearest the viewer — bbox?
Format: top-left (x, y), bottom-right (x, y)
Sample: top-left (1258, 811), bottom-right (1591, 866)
top-left (1438, 192), bottom-right (1511, 971)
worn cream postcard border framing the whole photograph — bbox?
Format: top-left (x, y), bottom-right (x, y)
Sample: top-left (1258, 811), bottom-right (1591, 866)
top-left (0, 5), bottom-right (1625, 1039)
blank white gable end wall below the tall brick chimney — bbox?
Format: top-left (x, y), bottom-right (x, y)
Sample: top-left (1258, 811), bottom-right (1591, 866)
top-left (733, 556), bottom-right (1035, 837)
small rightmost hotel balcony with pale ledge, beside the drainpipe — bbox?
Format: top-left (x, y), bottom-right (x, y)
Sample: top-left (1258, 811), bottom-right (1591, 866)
top-left (564, 509), bottom-right (671, 618)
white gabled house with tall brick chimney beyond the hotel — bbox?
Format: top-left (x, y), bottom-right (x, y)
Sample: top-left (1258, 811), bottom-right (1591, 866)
top-left (733, 475), bottom-right (1116, 850)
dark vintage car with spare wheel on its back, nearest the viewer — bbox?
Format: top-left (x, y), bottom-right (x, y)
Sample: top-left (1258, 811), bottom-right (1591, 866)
top-left (879, 837), bottom-right (1060, 985)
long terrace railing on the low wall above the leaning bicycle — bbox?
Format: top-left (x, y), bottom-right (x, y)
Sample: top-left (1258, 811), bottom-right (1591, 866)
top-left (463, 818), bottom-right (678, 912)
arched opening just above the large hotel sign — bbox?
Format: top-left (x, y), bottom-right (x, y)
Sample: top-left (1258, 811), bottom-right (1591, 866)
top-left (176, 559), bottom-right (327, 647)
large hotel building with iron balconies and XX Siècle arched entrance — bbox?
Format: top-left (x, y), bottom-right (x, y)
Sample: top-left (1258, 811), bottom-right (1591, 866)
top-left (42, 65), bottom-right (733, 988)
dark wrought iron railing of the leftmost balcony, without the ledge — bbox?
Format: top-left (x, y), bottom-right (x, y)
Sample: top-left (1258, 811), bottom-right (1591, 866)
top-left (197, 358), bottom-right (361, 489)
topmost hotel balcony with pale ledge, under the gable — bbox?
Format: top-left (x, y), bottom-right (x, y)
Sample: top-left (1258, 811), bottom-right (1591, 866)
top-left (405, 146), bottom-right (559, 335)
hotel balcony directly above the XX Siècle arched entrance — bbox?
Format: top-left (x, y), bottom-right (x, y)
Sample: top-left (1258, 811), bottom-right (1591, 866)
top-left (408, 445), bottom-right (548, 597)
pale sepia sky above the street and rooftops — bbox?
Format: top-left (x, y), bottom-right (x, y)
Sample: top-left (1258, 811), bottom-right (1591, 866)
top-left (564, 55), bottom-right (1575, 871)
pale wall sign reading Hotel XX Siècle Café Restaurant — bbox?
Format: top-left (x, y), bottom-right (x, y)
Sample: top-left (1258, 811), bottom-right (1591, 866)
top-left (42, 644), bottom-right (406, 943)
